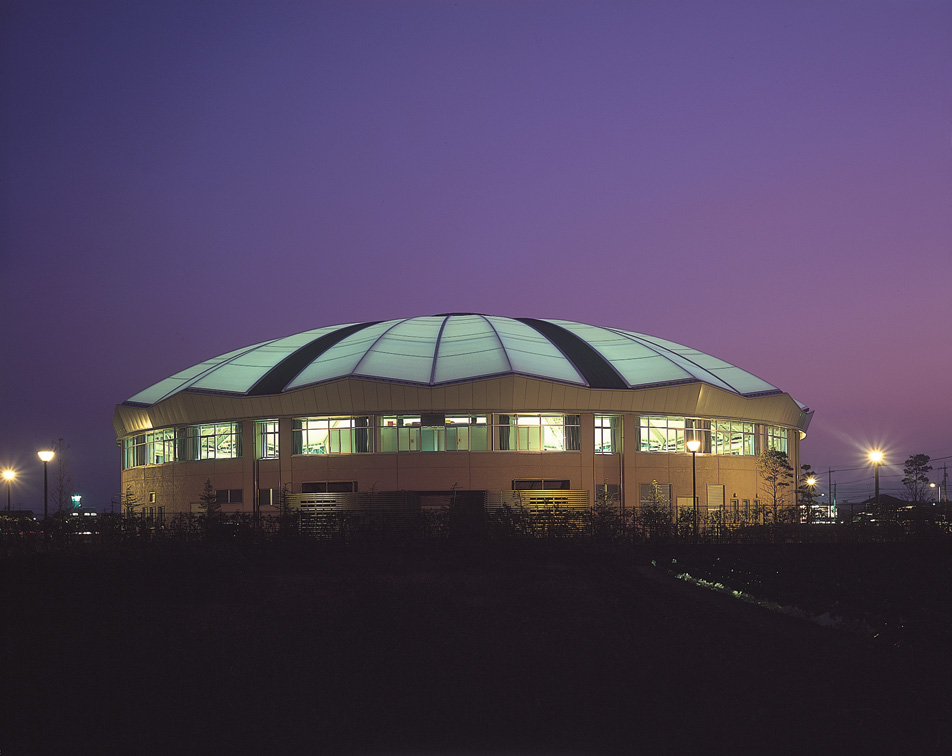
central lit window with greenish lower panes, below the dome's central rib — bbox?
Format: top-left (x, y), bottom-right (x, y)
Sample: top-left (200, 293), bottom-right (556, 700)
top-left (379, 413), bottom-right (489, 452)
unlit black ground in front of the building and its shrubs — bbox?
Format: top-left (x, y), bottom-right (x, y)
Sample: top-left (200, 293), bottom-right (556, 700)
top-left (0, 543), bottom-right (952, 756)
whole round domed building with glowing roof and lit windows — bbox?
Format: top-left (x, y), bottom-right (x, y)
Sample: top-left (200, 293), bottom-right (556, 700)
top-left (113, 313), bottom-right (812, 522)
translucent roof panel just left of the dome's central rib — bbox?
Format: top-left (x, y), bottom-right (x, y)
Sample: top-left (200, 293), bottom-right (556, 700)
top-left (354, 317), bottom-right (445, 383)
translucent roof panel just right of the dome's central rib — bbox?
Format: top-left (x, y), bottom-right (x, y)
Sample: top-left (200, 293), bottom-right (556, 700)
top-left (433, 315), bottom-right (512, 383)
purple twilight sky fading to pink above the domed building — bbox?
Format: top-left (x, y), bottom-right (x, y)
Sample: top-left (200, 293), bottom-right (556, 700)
top-left (0, 0), bottom-right (952, 512)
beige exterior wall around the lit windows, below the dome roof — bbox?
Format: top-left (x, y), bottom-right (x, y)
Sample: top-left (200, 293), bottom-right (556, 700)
top-left (114, 376), bottom-right (810, 515)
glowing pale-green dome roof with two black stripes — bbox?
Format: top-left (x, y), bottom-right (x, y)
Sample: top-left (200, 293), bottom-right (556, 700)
top-left (126, 313), bottom-right (783, 406)
